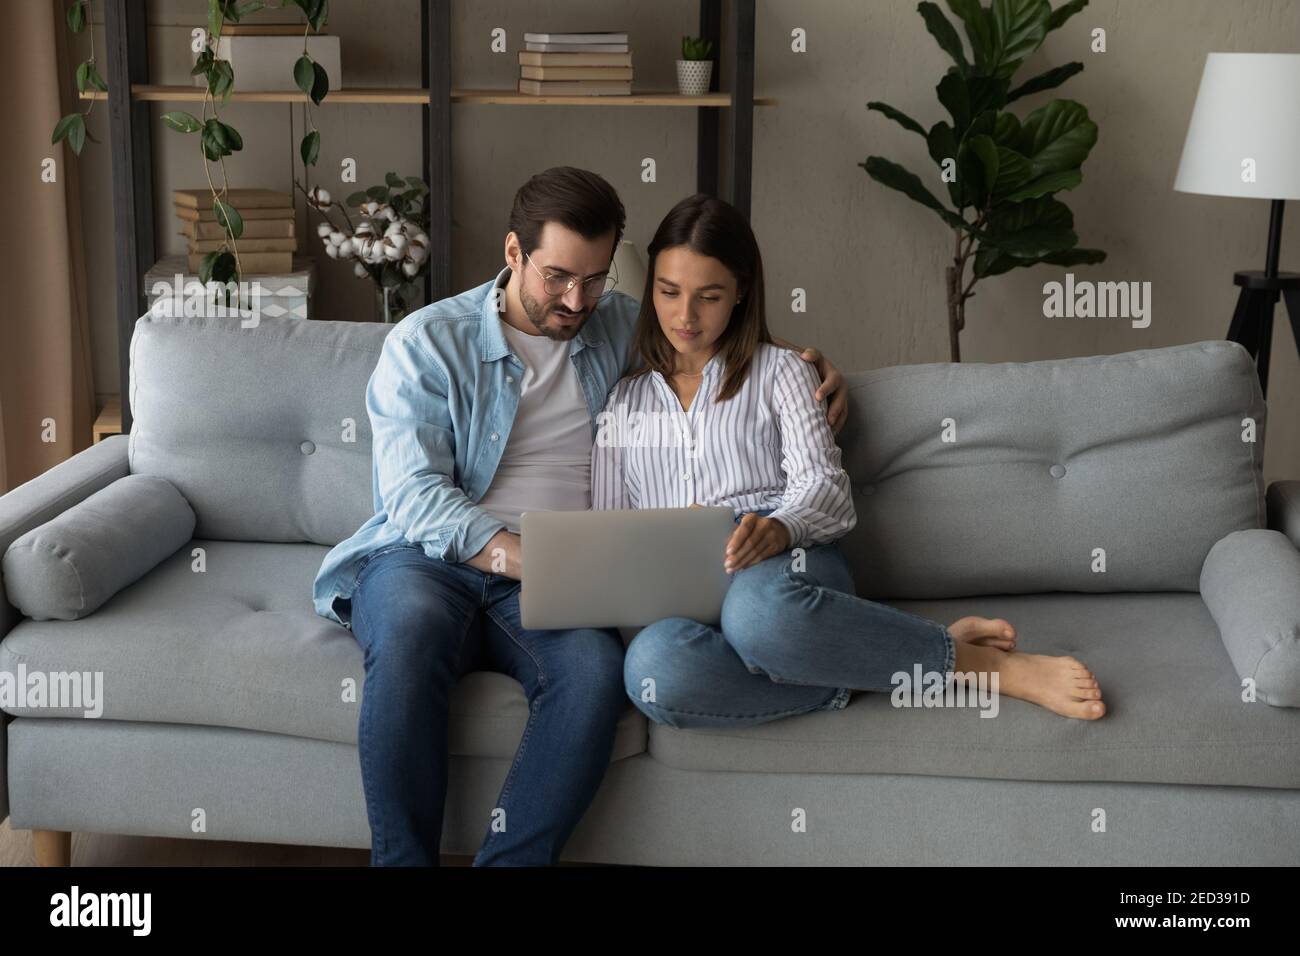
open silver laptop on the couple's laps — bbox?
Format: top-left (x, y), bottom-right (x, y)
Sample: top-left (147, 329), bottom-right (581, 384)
top-left (519, 507), bottom-right (736, 630)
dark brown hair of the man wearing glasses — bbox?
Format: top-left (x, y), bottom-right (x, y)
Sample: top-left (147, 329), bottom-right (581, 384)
top-left (510, 166), bottom-right (627, 256)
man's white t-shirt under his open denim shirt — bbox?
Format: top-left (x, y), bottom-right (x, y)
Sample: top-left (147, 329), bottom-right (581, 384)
top-left (478, 317), bottom-right (592, 533)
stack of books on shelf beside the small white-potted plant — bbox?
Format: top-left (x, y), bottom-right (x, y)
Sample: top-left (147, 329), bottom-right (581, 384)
top-left (519, 33), bottom-right (632, 96)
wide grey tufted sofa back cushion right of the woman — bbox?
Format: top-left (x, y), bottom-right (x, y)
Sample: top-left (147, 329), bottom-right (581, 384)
top-left (840, 342), bottom-right (1265, 598)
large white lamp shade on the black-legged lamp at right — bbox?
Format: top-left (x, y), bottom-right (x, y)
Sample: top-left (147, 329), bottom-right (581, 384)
top-left (1174, 53), bottom-right (1300, 199)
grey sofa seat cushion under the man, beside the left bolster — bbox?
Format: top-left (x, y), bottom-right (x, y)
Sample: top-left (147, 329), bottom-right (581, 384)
top-left (0, 540), bottom-right (646, 760)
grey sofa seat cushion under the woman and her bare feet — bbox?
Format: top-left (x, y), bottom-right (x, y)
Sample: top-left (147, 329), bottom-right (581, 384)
top-left (650, 592), bottom-right (1300, 788)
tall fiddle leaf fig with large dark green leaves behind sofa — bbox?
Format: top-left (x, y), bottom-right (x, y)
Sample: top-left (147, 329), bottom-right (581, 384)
top-left (858, 0), bottom-right (1106, 362)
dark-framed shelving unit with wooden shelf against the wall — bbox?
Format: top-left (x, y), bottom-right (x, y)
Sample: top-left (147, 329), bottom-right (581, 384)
top-left (106, 0), bottom-right (775, 433)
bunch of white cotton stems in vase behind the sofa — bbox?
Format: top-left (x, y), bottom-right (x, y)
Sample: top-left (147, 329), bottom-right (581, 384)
top-left (295, 173), bottom-right (429, 323)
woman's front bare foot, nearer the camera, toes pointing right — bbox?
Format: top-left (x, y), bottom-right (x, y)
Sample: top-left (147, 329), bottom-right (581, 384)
top-left (954, 641), bottom-right (1106, 721)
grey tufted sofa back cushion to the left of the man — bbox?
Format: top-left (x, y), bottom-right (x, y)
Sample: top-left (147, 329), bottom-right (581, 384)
top-left (130, 315), bottom-right (393, 545)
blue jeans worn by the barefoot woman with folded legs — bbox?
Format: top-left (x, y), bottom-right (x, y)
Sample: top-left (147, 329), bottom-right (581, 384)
top-left (623, 522), bottom-right (956, 727)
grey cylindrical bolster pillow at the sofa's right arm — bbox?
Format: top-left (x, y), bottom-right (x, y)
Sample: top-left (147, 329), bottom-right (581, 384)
top-left (1201, 529), bottom-right (1300, 708)
